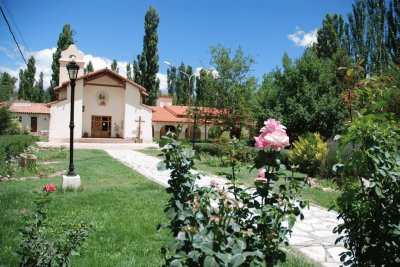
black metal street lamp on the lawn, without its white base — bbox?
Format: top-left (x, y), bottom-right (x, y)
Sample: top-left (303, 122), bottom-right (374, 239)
top-left (67, 61), bottom-right (79, 176)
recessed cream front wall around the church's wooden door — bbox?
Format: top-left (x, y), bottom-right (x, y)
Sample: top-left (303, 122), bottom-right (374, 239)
top-left (82, 77), bottom-right (125, 137)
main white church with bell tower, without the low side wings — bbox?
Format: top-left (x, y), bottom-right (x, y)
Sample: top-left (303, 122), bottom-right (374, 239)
top-left (49, 44), bottom-right (153, 143)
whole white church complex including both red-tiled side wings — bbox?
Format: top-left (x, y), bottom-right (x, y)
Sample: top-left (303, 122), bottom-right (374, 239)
top-left (10, 44), bottom-right (218, 143)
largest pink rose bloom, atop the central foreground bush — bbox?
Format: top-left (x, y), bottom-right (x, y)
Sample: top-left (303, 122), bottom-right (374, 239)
top-left (254, 119), bottom-right (290, 151)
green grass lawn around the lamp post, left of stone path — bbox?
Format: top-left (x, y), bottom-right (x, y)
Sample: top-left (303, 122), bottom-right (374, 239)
top-left (0, 149), bottom-right (317, 267)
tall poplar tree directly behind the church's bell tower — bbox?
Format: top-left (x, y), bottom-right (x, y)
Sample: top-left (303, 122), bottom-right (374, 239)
top-left (49, 24), bottom-right (74, 101)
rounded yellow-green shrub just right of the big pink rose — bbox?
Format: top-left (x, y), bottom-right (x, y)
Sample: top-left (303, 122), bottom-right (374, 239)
top-left (289, 133), bottom-right (328, 176)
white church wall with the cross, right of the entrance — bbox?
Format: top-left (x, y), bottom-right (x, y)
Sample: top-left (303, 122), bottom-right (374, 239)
top-left (124, 84), bottom-right (153, 143)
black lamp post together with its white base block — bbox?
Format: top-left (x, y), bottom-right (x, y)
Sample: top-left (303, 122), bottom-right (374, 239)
top-left (62, 61), bottom-right (80, 189)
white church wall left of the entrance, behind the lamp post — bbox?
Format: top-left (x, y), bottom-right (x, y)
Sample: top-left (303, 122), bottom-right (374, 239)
top-left (49, 80), bottom-right (83, 140)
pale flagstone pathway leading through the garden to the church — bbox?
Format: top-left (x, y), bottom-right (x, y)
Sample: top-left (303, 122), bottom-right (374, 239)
top-left (104, 149), bottom-right (345, 267)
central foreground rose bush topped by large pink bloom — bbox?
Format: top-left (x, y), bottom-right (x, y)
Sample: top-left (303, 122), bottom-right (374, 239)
top-left (158, 119), bottom-right (306, 266)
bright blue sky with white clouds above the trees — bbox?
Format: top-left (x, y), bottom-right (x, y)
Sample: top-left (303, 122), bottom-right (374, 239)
top-left (0, 0), bottom-right (353, 91)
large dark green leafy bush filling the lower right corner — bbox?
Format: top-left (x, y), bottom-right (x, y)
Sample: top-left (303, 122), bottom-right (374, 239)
top-left (334, 114), bottom-right (400, 266)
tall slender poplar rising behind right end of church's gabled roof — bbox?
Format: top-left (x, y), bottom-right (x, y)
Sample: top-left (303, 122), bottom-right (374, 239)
top-left (138, 7), bottom-right (160, 106)
